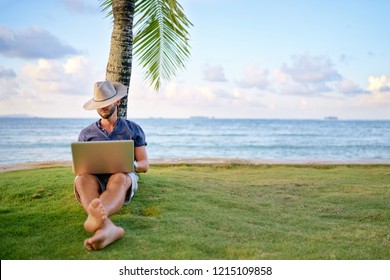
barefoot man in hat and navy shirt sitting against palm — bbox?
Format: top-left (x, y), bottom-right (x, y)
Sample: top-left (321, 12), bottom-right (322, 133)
top-left (74, 81), bottom-right (149, 250)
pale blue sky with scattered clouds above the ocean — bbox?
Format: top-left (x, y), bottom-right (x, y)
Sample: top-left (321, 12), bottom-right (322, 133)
top-left (0, 0), bottom-right (390, 120)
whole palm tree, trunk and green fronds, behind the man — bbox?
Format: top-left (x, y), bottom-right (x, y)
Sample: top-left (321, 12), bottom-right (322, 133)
top-left (101, 0), bottom-right (192, 118)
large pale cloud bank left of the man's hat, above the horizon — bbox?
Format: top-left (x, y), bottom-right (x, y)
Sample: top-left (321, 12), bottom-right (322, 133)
top-left (0, 56), bottom-right (105, 117)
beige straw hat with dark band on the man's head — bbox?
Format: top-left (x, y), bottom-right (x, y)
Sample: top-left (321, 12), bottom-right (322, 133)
top-left (83, 81), bottom-right (127, 110)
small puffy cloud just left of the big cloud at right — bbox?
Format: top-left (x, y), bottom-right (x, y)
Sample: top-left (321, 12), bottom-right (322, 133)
top-left (237, 64), bottom-right (269, 90)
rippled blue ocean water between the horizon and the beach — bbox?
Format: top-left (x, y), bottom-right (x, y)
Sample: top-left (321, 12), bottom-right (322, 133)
top-left (0, 118), bottom-right (390, 164)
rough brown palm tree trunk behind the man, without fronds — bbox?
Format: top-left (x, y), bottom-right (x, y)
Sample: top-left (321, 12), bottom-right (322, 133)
top-left (106, 0), bottom-right (135, 118)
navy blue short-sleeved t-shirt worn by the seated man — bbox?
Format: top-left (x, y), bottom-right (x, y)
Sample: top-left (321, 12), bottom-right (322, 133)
top-left (78, 118), bottom-right (147, 147)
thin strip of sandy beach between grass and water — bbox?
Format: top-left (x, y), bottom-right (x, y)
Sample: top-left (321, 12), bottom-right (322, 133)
top-left (0, 158), bottom-right (390, 172)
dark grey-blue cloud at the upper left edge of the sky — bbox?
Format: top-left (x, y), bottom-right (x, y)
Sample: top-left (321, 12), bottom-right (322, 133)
top-left (0, 25), bottom-right (79, 59)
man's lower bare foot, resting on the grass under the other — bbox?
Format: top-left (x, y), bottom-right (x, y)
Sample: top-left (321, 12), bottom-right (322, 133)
top-left (84, 219), bottom-right (125, 251)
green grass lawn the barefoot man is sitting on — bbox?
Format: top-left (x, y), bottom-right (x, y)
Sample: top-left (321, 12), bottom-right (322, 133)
top-left (0, 164), bottom-right (390, 260)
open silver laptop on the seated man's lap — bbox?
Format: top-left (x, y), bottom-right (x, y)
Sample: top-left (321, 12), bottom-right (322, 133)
top-left (71, 140), bottom-right (134, 175)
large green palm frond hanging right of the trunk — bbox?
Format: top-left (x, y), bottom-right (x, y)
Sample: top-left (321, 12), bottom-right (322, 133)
top-left (133, 0), bottom-right (192, 90)
